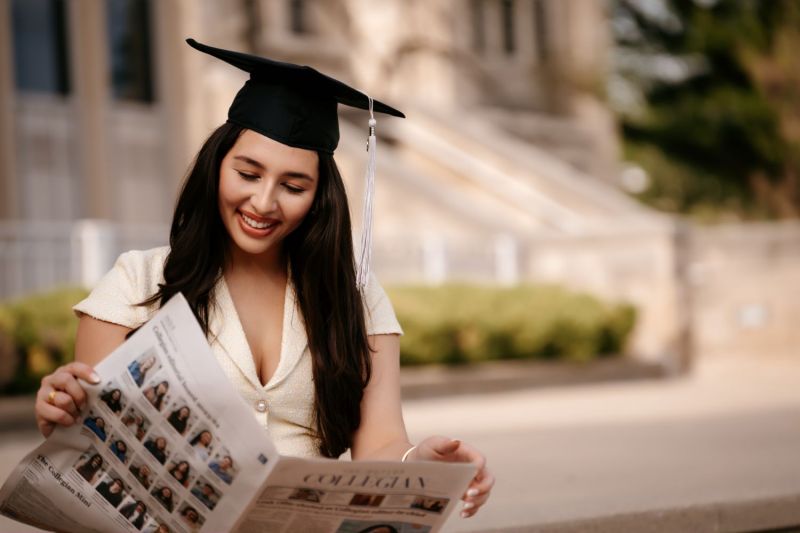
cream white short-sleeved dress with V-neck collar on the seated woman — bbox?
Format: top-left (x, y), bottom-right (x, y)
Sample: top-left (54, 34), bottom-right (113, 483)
top-left (73, 246), bottom-right (402, 457)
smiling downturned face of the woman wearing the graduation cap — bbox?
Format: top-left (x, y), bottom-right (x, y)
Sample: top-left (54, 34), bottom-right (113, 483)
top-left (218, 130), bottom-right (319, 256)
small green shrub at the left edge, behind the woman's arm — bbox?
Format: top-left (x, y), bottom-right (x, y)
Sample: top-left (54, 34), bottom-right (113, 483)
top-left (0, 288), bottom-right (87, 394)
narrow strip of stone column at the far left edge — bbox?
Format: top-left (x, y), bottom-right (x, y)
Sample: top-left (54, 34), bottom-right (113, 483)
top-left (0, 0), bottom-right (19, 220)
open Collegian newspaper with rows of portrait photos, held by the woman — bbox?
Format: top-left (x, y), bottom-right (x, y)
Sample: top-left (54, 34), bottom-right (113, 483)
top-left (0, 295), bottom-right (475, 533)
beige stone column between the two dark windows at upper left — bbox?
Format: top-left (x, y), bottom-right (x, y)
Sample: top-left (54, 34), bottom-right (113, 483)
top-left (67, 2), bottom-right (115, 219)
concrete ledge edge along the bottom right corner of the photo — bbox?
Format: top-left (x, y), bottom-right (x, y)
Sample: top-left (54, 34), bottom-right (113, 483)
top-left (485, 494), bottom-right (800, 533)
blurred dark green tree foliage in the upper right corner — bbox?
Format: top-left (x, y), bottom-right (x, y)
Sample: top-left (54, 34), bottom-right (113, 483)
top-left (614, 0), bottom-right (800, 216)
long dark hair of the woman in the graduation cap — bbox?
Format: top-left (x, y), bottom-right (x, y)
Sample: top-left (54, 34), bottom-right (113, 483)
top-left (142, 123), bottom-right (371, 457)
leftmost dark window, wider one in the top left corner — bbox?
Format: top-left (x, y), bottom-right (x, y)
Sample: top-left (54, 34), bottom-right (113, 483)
top-left (11, 0), bottom-right (70, 94)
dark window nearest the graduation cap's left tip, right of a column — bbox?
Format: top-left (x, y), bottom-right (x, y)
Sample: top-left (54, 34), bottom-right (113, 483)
top-left (108, 0), bottom-right (153, 102)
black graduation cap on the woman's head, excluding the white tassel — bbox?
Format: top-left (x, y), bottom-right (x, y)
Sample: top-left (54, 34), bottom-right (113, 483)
top-left (186, 39), bottom-right (405, 153)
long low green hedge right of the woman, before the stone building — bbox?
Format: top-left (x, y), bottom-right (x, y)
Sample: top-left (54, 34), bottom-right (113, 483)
top-left (387, 285), bottom-right (636, 365)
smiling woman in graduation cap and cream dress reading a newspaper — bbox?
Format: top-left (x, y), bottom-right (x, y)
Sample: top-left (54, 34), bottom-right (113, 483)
top-left (31, 40), bottom-right (494, 516)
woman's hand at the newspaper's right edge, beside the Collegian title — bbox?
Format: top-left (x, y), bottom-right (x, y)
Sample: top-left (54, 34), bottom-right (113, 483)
top-left (410, 437), bottom-right (494, 518)
